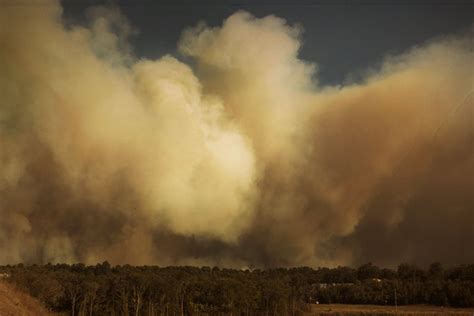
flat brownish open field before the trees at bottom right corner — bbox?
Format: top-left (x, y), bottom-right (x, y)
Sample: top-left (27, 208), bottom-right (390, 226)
top-left (308, 304), bottom-right (474, 316)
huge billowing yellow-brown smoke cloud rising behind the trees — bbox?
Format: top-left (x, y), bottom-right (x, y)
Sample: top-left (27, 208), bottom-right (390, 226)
top-left (0, 1), bottom-right (474, 267)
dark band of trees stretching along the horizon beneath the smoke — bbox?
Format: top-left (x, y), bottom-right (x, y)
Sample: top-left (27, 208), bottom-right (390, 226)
top-left (0, 262), bottom-right (474, 316)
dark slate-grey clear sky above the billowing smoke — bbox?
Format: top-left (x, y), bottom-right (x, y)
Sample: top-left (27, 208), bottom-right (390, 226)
top-left (63, 0), bottom-right (474, 84)
